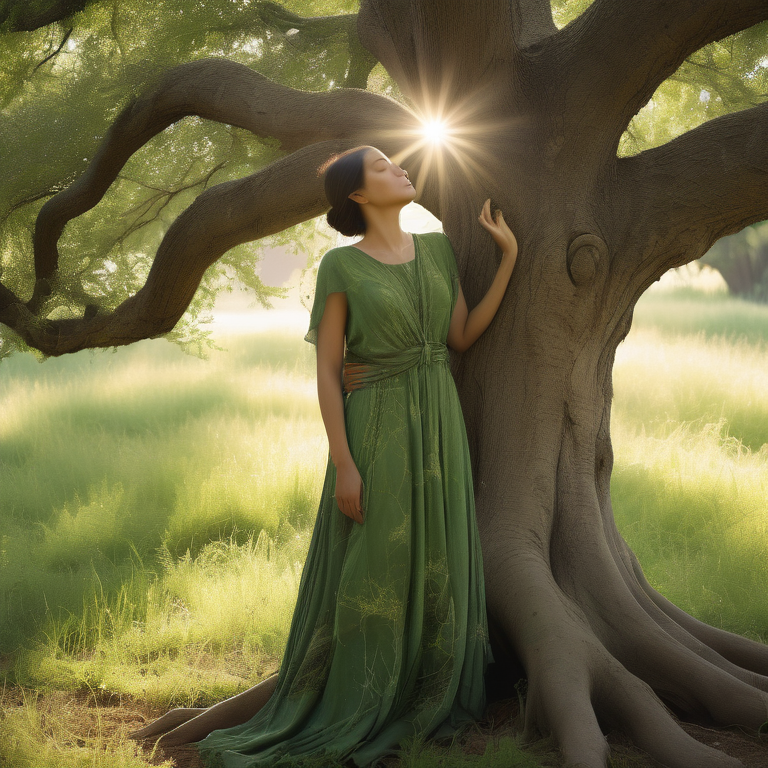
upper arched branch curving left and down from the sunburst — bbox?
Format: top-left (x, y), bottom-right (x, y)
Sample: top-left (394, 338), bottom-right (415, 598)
top-left (28, 59), bottom-right (413, 312)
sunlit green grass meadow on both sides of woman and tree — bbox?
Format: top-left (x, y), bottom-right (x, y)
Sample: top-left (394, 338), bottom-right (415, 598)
top-left (0, 290), bottom-right (768, 768)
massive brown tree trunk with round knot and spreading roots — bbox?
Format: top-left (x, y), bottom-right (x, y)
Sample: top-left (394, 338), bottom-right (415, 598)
top-left (361, 0), bottom-right (768, 768)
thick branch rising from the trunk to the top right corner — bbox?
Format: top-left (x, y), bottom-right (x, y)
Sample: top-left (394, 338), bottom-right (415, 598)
top-left (548, 0), bottom-right (768, 145)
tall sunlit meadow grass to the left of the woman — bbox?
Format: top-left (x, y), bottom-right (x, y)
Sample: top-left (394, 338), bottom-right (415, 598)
top-left (0, 338), bottom-right (327, 684)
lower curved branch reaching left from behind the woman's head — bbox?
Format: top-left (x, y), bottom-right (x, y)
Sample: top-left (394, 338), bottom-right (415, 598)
top-left (7, 141), bottom-right (350, 355)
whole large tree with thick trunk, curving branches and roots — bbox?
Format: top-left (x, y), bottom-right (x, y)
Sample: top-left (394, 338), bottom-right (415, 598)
top-left (0, 0), bottom-right (768, 768)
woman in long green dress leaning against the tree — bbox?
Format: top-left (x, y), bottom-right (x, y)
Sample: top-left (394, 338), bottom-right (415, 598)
top-left (132, 146), bottom-right (517, 768)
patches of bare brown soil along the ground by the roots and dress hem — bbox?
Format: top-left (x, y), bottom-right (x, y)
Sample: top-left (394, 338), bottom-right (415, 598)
top-left (0, 687), bottom-right (768, 768)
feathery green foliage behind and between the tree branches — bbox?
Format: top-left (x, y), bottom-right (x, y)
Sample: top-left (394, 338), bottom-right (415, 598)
top-left (0, 0), bottom-right (768, 360)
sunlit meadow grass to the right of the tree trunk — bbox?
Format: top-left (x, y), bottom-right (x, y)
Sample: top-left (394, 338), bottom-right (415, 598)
top-left (611, 320), bottom-right (768, 641)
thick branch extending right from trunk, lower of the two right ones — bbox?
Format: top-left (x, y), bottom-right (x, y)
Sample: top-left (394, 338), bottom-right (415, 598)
top-left (616, 102), bottom-right (768, 277)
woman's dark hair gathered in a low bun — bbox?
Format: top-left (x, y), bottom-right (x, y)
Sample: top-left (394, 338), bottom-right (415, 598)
top-left (317, 145), bottom-right (374, 237)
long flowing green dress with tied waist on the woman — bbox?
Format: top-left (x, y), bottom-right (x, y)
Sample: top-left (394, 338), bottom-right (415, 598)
top-left (197, 232), bottom-right (493, 768)
